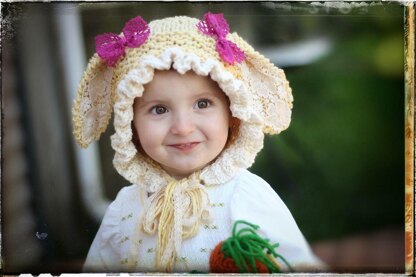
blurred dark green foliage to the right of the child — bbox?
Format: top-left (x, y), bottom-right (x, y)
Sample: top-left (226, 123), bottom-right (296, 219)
top-left (252, 5), bottom-right (404, 241)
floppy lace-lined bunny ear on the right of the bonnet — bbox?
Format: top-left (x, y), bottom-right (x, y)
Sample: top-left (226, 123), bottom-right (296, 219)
top-left (231, 33), bottom-right (293, 134)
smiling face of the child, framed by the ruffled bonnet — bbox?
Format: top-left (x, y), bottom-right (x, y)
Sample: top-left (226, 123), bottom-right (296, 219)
top-left (133, 70), bottom-right (230, 179)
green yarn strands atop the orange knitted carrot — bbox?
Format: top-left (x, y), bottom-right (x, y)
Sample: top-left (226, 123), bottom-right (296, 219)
top-left (221, 220), bottom-right (293, 273)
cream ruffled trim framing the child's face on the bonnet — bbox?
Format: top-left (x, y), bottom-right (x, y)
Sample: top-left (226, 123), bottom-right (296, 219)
top-left (111, 47), bottom-right (264, 193)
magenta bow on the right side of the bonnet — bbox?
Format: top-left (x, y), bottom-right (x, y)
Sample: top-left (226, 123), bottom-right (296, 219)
top-left (197, 12), bottom-right (246, 65)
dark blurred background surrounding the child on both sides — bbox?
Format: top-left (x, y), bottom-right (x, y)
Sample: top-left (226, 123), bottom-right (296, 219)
top-left (2, 2), bottom-right (405, 273)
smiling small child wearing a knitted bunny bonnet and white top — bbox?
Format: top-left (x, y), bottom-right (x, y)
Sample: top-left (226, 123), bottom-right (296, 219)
top-left (73, 13), bottom-right (322, 273)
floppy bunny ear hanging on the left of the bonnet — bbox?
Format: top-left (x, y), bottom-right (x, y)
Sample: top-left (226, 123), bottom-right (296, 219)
top-left (72, 54), bottom-right (113, 148)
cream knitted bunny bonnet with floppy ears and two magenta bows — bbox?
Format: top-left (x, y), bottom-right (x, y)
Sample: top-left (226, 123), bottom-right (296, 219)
top-left (73, 13), bottom-right (293, 267)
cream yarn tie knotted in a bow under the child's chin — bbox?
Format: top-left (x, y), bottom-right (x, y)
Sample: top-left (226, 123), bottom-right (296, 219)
top-left (142, 174), bottom-right (211, 272)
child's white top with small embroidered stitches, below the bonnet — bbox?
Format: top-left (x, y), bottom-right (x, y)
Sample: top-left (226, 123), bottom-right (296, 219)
top-left (84, 170), bottom-right (323, 272)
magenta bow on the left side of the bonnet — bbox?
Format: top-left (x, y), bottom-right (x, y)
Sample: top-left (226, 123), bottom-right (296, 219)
top-left (95, 16), bottom-right (150, 67)
